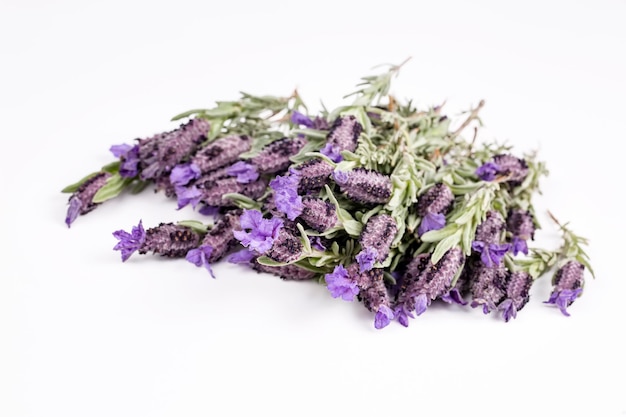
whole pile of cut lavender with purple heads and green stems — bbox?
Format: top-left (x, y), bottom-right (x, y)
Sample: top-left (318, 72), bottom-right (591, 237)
top-left (63, 61), bottom-right (593, 329)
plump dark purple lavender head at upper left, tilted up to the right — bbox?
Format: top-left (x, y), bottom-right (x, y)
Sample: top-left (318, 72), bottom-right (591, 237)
top-left (138, 118), bottom-right (209, 180)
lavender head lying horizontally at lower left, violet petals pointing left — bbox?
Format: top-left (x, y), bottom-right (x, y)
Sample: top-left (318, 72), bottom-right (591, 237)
top-left (113, 221), bottom-right (200, 261)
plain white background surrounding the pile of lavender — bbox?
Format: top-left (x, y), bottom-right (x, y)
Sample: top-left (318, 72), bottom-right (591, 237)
top-left (0, 0), bottom-right (626, 417)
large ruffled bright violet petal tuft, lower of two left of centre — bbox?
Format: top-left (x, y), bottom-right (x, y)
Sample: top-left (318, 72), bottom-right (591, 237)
top-left (233, 210), bottom-right (283, 254)
